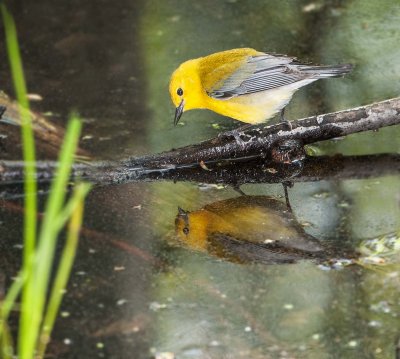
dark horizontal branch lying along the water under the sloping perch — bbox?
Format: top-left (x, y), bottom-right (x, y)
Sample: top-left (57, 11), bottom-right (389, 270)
top-left (0, 154), bottom-right (400, 199)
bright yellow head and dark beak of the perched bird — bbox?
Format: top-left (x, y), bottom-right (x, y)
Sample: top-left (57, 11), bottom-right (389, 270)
top-left (169, 59), bottom-right (204, 125)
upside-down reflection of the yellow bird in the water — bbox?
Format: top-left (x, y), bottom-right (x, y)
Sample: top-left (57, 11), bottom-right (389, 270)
top-left (175, 196), bottom-right (327, 264)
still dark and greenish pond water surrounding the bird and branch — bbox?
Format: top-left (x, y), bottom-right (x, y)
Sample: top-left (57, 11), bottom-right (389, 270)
top-left (0, 0), bottom-right (400, 358)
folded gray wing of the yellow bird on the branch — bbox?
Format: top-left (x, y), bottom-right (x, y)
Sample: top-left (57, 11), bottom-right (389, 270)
top-left (208, 54), bottom-right (312, 99)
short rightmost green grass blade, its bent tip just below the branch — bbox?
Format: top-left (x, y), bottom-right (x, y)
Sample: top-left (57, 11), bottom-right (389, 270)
top-left (37, 184), bottom-right (90, 358)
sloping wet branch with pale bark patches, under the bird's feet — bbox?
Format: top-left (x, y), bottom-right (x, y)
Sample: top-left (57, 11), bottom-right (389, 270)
top-left (107, 97), bottom-right (400, 174)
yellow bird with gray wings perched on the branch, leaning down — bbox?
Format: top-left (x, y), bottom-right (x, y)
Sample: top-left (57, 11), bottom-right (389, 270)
top-left (169, 48), bottom-right (352, 125)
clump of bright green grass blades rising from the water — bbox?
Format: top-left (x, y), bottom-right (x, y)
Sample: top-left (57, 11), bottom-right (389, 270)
top-left (0, 3), bottom-right (90, 359)
